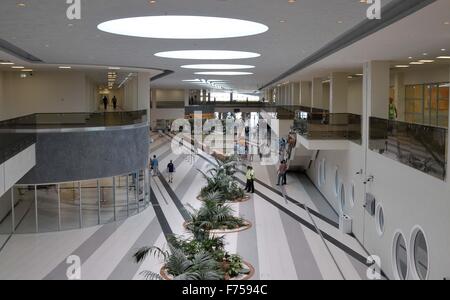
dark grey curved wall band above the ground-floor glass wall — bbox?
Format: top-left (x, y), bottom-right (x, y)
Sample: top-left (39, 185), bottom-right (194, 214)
top-left (19, 126), bottom-right (150, 184)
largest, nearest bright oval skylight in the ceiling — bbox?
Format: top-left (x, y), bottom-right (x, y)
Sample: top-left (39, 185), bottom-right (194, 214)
top-left (97, 16), bottom-right (269, 39)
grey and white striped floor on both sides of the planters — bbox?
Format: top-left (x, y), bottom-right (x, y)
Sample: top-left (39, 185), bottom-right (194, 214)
top-left (0, 135), bottom-right (368, 280)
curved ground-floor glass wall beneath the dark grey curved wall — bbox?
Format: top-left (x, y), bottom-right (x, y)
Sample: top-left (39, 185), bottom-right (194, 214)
top-left (0, 169), bottom-right (150, 234)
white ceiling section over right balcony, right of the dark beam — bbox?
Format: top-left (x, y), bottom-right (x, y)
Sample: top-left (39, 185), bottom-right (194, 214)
top-left (284, 0), bottom-right (450, 81)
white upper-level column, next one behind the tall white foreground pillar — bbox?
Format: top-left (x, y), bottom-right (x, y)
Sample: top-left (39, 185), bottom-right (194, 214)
top-left (330, 73), bottom-right (348, 113)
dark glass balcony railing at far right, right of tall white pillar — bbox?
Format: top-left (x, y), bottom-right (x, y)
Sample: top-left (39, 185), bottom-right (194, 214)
top-left (369, 117), bottom-right (448, 180)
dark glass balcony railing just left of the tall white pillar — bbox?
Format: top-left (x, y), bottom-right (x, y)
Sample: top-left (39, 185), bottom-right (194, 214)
top-left (293, 111), bottom-right (362, 145)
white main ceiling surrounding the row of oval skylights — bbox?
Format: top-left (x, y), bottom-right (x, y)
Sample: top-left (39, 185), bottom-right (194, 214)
top-left (0, 0), bottom-right (391, 91)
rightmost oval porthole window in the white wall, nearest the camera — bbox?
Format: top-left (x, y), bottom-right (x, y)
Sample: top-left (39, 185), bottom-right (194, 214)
top-left (411, 227), bottom-right (429, 280)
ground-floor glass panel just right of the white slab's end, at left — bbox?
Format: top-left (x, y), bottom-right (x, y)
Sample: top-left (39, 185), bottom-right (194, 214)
top-left (36, 185), bottom-right (59, 232)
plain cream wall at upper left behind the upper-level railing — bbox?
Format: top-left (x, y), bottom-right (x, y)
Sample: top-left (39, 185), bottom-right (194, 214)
top-left (2, 71), bottom-right (90, 119)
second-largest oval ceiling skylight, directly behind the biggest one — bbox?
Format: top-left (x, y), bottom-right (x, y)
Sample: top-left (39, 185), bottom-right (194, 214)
top-left (155, 50), bottom-right (261, 60)
